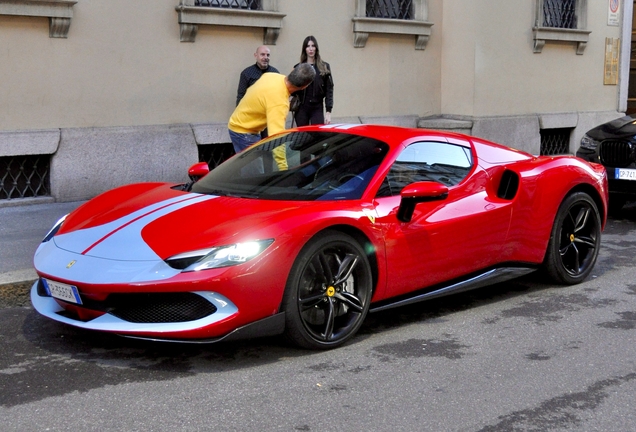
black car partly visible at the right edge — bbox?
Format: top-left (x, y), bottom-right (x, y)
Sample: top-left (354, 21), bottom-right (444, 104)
top-left (576, 116), bottom-right (636, 213)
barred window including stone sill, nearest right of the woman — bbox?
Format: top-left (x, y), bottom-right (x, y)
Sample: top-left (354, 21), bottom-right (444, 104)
top-left (352, 0), bottom-right (433, 50)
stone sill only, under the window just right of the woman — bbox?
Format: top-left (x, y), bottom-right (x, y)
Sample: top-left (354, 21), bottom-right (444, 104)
top-left (353, 17), bottom-right (433, 50)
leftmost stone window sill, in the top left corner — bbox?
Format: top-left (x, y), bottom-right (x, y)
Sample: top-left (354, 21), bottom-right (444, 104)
top-left (0, 0), bottom-right (77, 38)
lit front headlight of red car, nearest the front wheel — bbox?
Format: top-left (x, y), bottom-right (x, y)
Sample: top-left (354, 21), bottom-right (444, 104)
top-left (166, 239), bottom-right (274, 272)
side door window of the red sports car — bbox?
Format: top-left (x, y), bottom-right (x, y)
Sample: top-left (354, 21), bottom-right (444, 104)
top-left (378, 142), bottom-right (472, 196)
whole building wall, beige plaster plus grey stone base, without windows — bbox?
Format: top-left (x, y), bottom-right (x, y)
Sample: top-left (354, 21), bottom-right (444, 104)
top-left (0, 0), bottom-right (631, 204)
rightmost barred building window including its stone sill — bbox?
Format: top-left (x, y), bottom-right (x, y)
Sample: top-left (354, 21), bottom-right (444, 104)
top-left (532, 0), bottom-right (591, 55)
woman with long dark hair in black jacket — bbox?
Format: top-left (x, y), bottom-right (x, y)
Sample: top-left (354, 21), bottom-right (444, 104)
top-left (294, 36), bottom-right (333, 126)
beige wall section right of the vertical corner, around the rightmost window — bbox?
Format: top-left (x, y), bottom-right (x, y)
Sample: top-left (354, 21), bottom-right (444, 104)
top-left (436, 0), bottom-right (620, 116)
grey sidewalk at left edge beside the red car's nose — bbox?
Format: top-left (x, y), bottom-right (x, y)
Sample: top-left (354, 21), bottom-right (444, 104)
top-left (0, 200), bottom-right (84, 305)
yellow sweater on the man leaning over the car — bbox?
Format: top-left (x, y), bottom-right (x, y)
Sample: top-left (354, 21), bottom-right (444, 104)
top-left (227, 72), bottom-right (290, 135)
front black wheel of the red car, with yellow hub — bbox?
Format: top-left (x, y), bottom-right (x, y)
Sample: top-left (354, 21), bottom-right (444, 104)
top-left (283, 231), bottom-right (373, 349)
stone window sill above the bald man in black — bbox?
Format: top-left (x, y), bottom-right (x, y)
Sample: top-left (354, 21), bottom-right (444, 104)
top-left (175, 5), bottom-right (285, 45)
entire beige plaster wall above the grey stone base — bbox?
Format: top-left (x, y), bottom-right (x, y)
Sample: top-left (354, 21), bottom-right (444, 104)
top-left (0, 0), bottom-right (619, 130)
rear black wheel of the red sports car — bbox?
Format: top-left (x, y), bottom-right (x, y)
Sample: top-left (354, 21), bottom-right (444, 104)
top-left (544, 192), bottom-right (601, 284)
